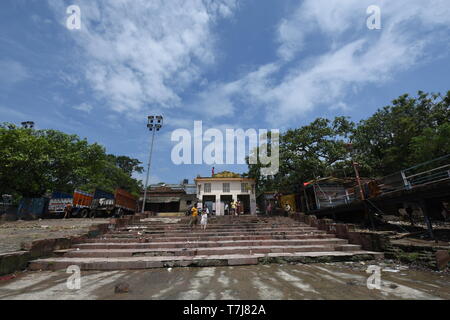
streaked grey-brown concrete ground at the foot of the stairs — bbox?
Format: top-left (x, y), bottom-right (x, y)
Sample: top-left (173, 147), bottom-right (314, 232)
top-left (0, 262), bottom-right (450, 300)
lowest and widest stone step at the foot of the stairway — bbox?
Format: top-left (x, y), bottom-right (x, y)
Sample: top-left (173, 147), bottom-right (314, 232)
top-left (28, 251), bottom-right (383, 271)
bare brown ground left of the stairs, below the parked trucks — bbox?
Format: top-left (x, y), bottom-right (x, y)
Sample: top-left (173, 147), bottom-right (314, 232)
top-left (0, 219), bottom-right (109, 253)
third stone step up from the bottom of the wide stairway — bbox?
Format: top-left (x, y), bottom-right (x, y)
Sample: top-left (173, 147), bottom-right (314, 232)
top-left (74, 238), bottom-right (348, 250)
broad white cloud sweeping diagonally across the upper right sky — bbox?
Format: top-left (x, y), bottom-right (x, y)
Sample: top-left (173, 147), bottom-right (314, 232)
top-left (195, 0), bottom-right (450, 125)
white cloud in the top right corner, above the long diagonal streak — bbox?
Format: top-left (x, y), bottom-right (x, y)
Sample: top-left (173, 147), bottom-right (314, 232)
top-left (277, 0), bottom-right (450, 58)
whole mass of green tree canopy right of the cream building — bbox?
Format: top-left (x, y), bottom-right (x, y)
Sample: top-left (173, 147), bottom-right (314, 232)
top-left (246, 91), bottom-right (450, 193)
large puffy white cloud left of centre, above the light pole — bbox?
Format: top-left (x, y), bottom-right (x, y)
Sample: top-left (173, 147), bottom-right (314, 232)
top-left (48, 0), bottom-right (237, 117)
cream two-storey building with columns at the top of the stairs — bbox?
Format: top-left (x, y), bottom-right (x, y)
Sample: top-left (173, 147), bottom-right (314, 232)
top-left (195, 172), bottom-right (256, 215)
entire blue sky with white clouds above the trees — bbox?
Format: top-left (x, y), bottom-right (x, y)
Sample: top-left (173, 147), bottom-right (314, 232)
top-left (0, 0), bottom-right (450, 183)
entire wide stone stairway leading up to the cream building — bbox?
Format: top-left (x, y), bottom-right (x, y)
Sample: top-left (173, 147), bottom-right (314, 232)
top-left (29, 216), bottom-right (382, 270)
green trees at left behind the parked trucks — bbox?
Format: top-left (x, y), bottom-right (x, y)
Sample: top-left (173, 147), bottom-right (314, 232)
top-left (0, 124), bottom-right (142, 197)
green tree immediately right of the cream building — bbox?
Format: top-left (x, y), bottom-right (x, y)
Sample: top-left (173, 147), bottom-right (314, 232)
top-left (247, 117), bottom-right (354, 192)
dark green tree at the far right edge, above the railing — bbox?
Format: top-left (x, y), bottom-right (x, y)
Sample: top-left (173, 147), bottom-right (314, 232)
top-left (352, 91), bottom-right (450, 176)
